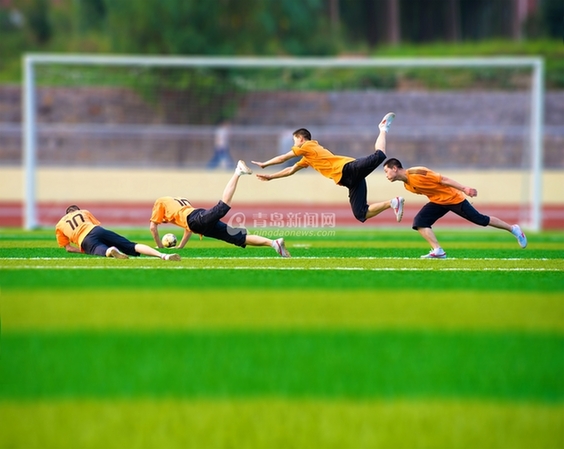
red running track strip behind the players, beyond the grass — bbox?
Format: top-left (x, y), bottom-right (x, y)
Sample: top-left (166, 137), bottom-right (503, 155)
top-left (0, 201), bottom-right (564, 230)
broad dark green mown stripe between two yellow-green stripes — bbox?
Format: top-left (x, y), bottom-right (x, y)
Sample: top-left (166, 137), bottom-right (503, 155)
top-left (0, 331), bottom-right (564, 403)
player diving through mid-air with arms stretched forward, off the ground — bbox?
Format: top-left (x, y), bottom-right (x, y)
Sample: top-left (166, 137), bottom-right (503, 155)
top-left (252, 112), bottom-right (404, 223)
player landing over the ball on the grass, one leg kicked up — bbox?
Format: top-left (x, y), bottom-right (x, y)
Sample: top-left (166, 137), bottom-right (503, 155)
top-left (149, 161), bottom-right (290, 257)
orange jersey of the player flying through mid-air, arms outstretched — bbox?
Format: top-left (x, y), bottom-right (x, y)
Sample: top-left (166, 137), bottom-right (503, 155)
top-left (292, 140), bottom-right (354, 184)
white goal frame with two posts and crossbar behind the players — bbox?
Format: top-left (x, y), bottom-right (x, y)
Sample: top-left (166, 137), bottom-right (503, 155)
top-left (22, 54), bottom-right (544, 231)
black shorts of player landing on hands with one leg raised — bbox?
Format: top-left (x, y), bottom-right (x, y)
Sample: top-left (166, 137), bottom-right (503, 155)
top-left (186, 201), bottom-right (247, 248)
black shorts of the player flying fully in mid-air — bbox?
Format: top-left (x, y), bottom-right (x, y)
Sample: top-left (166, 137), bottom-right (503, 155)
top-left (339, 150), bottom-right (386, 223)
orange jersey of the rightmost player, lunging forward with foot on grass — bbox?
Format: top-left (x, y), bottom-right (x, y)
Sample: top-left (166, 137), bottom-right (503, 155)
top-left (404, 167), bottom-right (465, 204)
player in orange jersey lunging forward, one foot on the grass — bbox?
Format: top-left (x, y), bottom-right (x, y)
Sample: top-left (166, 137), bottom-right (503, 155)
top-left (384, 158), bottom-right (527, 259)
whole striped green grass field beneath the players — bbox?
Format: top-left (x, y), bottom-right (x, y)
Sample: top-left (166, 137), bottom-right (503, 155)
top-left (0, 227), bottom-right (564, 449)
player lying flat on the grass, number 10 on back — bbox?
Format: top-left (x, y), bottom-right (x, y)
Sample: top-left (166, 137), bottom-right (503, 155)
top-left (55, 205), bottom-right (180, 260)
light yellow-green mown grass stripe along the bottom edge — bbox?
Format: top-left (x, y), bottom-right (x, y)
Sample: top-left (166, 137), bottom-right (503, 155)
top-left (0, 398), bottom-right (564, 449)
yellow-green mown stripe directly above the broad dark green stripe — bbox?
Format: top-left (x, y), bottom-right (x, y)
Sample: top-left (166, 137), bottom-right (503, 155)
top-left (0, 286), bottom-right (564, 335)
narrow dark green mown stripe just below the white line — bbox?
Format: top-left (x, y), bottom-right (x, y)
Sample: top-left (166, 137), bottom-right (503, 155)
top-left (0, 266), bottom-right (564, 290)
